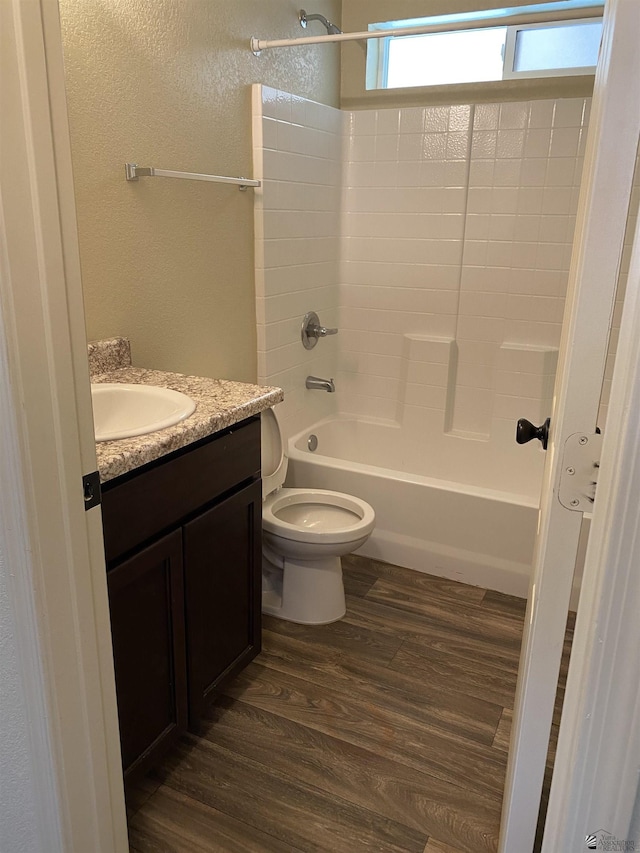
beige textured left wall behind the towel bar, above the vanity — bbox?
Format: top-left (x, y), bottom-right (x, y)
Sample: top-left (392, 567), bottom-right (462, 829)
top-left (60, 0), bottom-right (341, 381)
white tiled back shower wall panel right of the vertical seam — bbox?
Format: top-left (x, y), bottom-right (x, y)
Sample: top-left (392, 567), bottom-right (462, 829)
top-left (452, 99), bottom-right (586, 436)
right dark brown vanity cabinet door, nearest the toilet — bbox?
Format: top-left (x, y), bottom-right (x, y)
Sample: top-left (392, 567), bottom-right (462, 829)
top-left (183, 481), bottom-right (262, 727)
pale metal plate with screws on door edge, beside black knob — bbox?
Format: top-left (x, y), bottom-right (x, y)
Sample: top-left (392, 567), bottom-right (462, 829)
top-left (558, 432), bottom-right (602, 512)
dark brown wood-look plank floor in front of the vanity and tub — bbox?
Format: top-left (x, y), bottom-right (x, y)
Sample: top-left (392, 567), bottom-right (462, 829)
top-left (128, 555), bottom-right (571, 853)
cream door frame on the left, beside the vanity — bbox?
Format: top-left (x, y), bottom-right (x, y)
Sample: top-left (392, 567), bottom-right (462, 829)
top-left (0, 0), bottom-right (128, 853)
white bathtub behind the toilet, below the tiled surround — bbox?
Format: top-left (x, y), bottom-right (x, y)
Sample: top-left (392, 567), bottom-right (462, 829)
top-left (287, 416), bottom-right (544, 597)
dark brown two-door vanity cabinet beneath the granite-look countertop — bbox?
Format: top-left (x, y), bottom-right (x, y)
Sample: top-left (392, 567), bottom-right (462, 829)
top-left (102, 417), bottom-right (262, 778)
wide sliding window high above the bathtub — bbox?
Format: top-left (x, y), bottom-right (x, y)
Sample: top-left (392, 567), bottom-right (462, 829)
top-left (367, 0), bottom-right (602, 89)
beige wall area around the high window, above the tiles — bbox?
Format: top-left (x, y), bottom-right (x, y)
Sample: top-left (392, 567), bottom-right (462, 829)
top-left (341, 0), bottom-right (593, 109)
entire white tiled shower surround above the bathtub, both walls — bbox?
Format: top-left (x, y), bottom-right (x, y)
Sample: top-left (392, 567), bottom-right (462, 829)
top-left (254, 86), bottom-right (589, 442)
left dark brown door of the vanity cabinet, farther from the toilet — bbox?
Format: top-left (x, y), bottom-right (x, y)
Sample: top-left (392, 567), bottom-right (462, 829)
top-left (107, 531), bottom-right (187, 778)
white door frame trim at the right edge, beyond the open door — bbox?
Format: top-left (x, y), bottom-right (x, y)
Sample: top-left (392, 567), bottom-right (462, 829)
top-left (542, 120), bottom-right (640, 853)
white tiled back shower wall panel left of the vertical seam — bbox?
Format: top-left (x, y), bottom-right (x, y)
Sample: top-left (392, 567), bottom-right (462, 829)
top-left (338, 106), bottom-right (471, 422)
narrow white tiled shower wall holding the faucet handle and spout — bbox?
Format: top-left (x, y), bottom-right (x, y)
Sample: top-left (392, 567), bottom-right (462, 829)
top-left (252, 85), bottom-right (344, 433)
